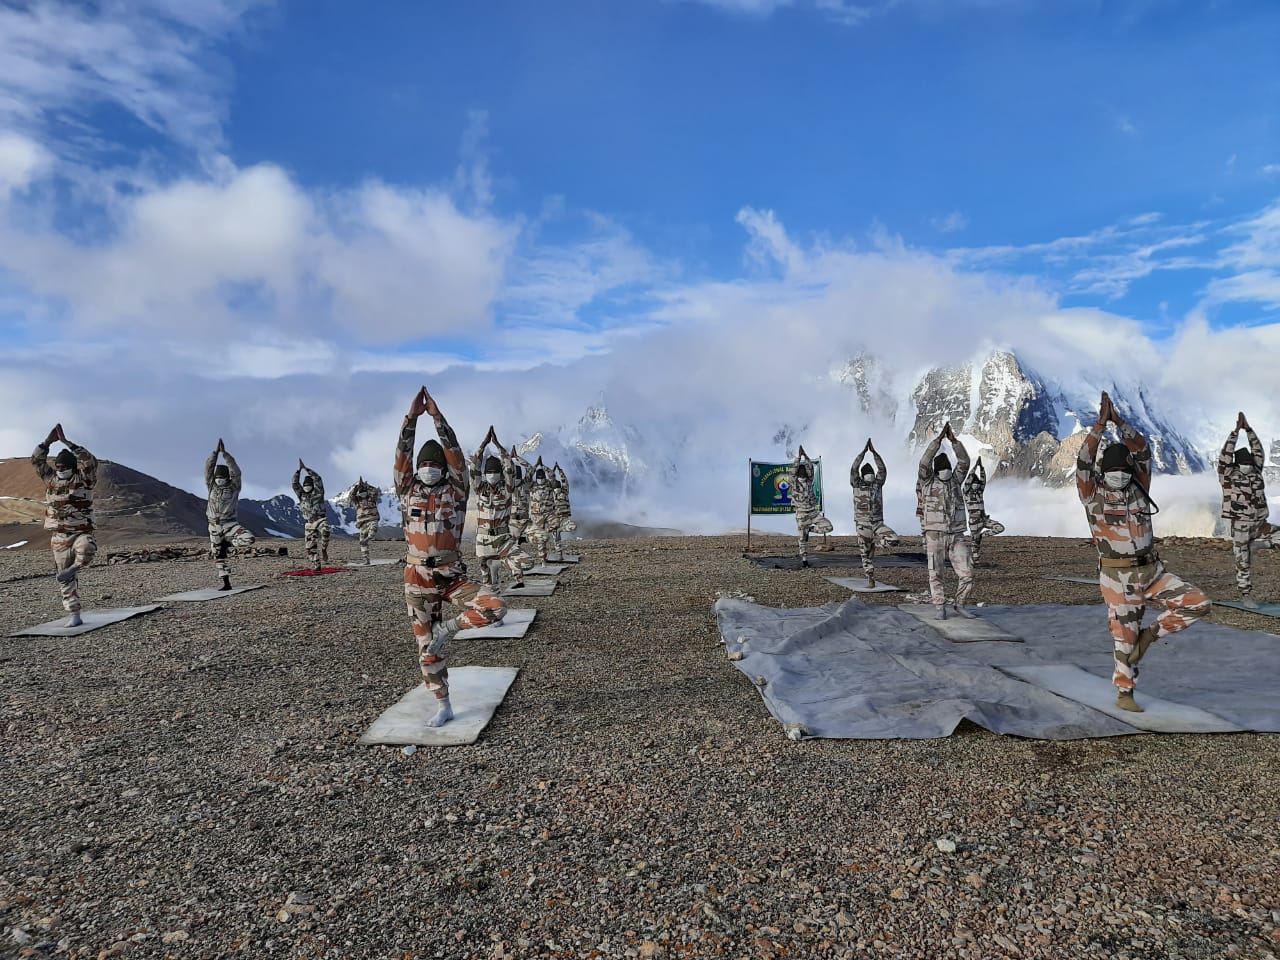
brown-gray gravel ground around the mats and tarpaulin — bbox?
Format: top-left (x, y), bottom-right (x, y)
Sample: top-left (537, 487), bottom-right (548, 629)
top-left (0, 536), bottom-right (1280, 960)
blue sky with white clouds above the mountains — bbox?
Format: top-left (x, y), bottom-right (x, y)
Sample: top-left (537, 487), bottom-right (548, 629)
top-left (0, 0), bottom-right (1280, 514)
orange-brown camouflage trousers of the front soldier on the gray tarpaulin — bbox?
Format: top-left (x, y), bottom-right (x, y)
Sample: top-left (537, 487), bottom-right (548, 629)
top-left (1098, 561), bottom-right (1210, 690)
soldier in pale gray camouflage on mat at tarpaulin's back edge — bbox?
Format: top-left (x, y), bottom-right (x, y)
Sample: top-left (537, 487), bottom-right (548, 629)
top-left (915, 424), bottom-right (974, 620)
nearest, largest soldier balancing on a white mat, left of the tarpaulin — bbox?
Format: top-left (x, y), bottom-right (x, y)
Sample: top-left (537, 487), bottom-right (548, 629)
top-left (396, 387), bottom-right (507, 727)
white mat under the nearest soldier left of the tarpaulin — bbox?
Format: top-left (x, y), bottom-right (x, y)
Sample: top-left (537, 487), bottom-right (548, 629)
top-left (360, 667), bottom-right (520, 746)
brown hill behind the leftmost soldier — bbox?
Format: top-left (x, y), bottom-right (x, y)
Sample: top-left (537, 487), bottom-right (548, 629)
top-left (0, 457), bottom-right (209, 550)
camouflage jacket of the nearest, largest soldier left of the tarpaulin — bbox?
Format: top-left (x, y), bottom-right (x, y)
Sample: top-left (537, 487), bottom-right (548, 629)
top-left (394, 416), bottom-right (467, 576)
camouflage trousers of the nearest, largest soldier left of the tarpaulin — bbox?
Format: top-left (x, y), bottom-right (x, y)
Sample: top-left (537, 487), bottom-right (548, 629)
top-left (404, 563), bottom-right (507, 700)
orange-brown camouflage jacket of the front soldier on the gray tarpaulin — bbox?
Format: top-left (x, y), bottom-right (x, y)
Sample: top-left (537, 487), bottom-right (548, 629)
top-left (1075, 424), bottom-right (1155, 559)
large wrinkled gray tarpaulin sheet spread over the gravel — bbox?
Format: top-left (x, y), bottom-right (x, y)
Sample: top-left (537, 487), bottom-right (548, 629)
top-left (716, 599), bottom-right (1280, 740)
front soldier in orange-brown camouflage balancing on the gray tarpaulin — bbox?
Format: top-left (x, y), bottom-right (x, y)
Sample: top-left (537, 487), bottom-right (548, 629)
top-left (1075, 393), bottom-right (1210, 713)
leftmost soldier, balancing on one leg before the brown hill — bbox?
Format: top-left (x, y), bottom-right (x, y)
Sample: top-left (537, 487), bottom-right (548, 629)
top-left (31, 424), bottom-right (97, 627)
